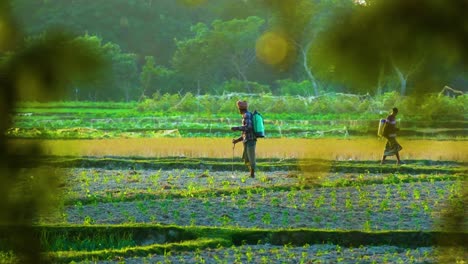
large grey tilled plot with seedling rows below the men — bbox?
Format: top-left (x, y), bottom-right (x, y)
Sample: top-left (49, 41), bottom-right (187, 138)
top-left (55, 169), bottom-right (468, 231)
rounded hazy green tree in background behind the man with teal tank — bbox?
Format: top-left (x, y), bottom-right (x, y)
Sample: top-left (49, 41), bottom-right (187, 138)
top-left (172, 17), bottom-right (264, 93)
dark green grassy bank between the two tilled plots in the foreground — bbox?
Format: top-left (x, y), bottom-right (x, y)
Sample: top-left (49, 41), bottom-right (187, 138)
top-left (1, 225), bottom-right (467, 263)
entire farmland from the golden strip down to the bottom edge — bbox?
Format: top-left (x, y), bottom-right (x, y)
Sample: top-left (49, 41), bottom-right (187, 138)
top-left (3, 102), bottom-right (468, 263)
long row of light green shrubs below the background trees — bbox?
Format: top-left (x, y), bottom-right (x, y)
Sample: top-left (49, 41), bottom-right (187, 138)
top-left (137, 92), bottom-right (468, 120)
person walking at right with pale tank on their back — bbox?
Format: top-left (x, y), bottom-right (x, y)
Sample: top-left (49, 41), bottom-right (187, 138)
top-left (380, 107), bottom-right (403, 165)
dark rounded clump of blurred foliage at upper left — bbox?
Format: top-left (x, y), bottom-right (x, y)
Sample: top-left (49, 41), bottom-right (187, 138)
top-left (10, 30), bottom-right (106, 101)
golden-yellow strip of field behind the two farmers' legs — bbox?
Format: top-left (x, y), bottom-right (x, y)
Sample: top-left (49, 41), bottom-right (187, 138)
top-left (15, 138), bottom-right (468, 162)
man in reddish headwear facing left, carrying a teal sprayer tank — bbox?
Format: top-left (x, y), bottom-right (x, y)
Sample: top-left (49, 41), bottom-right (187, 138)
top-left (231, 101), bottom-right (257, 178)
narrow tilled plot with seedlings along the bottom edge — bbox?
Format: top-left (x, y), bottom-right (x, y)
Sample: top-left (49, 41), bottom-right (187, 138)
top-left (99, 244), bottom-right (438, 264)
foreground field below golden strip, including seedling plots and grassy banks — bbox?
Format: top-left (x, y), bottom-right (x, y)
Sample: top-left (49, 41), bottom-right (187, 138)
top-left (15, 156), bottom-right (468, 263)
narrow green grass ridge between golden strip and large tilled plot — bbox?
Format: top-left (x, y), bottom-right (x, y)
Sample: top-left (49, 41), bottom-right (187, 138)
top-left (22, 156), bottom-right (468, 174)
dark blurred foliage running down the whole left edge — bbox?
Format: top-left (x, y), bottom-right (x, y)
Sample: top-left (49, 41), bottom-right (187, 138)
top-left (0, 1), bottom-right (104, 263)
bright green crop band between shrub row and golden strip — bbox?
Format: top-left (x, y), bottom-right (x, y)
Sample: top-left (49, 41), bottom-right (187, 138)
top-left (8, 104), bottom-right (466, 138)
